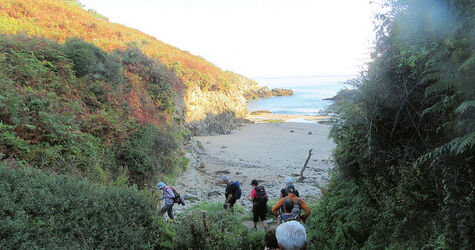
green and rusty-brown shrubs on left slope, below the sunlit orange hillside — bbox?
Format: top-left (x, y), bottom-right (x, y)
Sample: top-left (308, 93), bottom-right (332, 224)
top-left (0, 35), bottom-right (187, 187)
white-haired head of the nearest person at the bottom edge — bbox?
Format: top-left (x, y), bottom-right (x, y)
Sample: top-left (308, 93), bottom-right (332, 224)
top-left (275, 221), bottom-right (307, 250)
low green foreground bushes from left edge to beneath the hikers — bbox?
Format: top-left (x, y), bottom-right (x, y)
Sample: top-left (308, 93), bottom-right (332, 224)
top-left (0, 165), bottom-right (264, 249)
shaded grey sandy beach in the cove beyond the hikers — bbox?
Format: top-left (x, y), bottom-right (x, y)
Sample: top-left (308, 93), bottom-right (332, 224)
top-left (175, 116), bottom-right (335, 210)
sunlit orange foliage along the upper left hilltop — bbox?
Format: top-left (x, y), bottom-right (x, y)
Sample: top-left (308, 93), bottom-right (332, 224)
top-left (0, 0), bottom-right (232, 90)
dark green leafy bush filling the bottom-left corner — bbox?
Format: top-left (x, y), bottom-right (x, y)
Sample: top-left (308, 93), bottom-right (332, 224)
top-left (0, 166), bottom-right (174, 249)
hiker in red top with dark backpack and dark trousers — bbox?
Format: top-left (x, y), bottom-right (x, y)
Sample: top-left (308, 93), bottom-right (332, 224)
top-left (247, 180), bottom-right (269, 231)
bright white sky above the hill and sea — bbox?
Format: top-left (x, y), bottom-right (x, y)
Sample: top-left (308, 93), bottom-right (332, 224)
top-left (79, 0), bottom-right (376, 78)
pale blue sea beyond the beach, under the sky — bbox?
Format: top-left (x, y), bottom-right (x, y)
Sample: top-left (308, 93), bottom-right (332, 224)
top-left (247, 75), bottom-right (355, 115)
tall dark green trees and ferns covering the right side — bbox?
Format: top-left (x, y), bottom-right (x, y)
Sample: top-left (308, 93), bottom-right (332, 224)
top-left (309, 0), bottom-right (475, 249)
